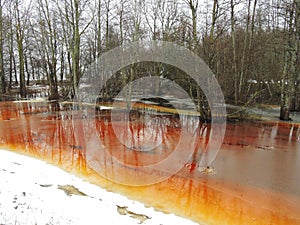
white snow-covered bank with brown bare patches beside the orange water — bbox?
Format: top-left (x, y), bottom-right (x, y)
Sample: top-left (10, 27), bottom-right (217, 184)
top-left (0, 150), bottom-right (196, 225)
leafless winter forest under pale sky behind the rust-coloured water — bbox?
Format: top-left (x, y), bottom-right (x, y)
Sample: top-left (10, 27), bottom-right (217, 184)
top-left (0, 0), bottom-right (300, 120)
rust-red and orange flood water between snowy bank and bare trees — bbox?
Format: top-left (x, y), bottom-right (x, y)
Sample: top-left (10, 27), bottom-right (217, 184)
top-left (0, 102), bottom-right (300, 225)
